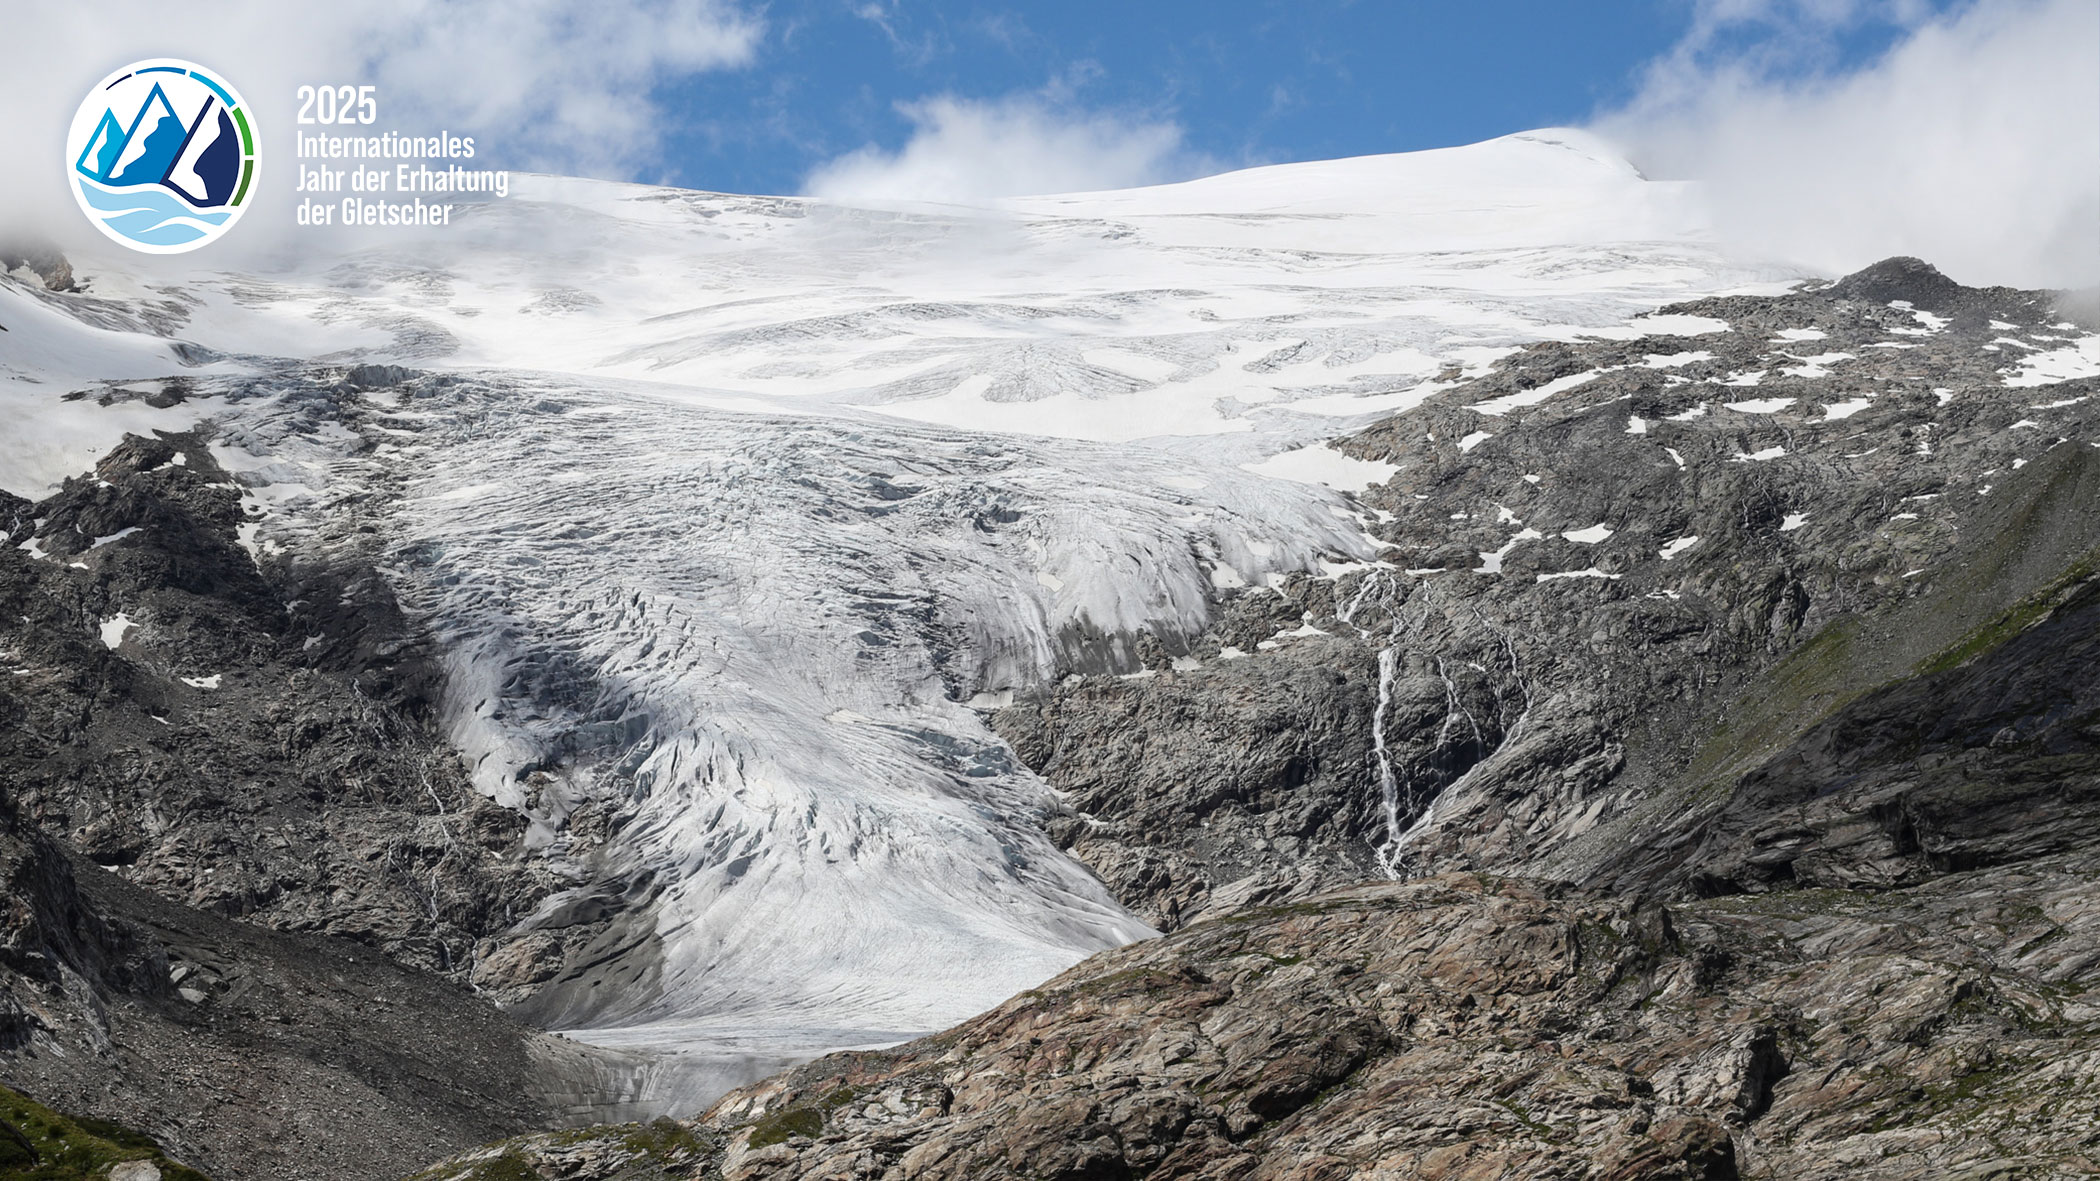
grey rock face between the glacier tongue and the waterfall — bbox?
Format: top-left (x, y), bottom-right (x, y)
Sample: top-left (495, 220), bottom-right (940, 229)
top-left (993, 626), bottom-right (1384, 931)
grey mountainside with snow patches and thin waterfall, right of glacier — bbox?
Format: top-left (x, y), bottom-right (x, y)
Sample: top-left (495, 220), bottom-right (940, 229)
top-left (995, 258), bottom-right (2100, 927)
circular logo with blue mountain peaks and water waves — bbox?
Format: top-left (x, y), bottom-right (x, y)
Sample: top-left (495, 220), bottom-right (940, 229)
top-left (65, 57), bottom-right (256, 254)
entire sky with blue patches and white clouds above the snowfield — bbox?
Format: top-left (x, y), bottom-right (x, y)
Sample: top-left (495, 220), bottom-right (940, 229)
top-left (0, 0), bottom-right (2100, 286)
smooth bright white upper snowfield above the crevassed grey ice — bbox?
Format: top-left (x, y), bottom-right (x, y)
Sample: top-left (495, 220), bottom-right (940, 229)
top-left (8, 130), bottom-right (1787, 464)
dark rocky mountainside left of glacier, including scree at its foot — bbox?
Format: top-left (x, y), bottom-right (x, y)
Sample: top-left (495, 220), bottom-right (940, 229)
top-left (0, 426), bottom-right (613, 1181)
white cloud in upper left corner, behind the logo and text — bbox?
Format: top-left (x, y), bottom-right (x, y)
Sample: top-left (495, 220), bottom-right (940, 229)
top-left (0, 0), bottom-right (762, 233)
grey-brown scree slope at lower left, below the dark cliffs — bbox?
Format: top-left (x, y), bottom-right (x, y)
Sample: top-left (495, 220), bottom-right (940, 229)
top-left (0, 823), bottom-right (590, 1181)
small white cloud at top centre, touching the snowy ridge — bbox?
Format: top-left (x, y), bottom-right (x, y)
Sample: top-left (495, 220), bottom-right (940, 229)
top-left (804, 88), bottom-right (1218, 202)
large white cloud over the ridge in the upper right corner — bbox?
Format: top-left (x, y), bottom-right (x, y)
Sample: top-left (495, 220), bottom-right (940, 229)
top-left (1596, 0), bottom-right (2100, 286)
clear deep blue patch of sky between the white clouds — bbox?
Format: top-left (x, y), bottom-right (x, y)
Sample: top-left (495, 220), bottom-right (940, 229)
top-left (638, 0), bottom-right (1932, 193)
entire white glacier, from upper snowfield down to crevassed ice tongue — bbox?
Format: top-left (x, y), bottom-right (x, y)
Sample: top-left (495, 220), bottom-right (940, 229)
top-left (0, 130), bottom-right (1787, 1101)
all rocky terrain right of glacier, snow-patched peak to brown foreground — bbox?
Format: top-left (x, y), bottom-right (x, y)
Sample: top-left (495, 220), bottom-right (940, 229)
top-left (405, 261), bottom-right (2100, 1179)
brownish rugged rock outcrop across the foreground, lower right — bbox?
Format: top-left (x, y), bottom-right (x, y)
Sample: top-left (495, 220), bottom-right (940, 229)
top-left (418, 853), bottom-right (2100, 1181)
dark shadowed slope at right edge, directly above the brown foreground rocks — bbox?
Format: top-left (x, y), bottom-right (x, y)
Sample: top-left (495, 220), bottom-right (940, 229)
top-left (1632, 521), bottom-right (2100, 893)
